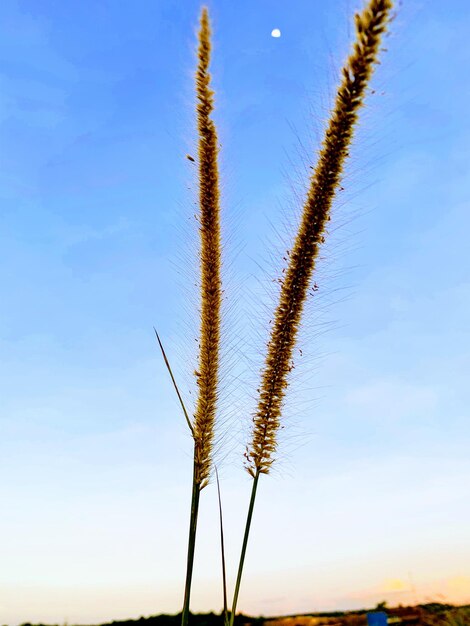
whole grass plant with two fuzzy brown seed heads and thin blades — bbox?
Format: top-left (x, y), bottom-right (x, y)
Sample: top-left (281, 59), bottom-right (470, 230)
top-left (157, 0), bottom-right (393, 626)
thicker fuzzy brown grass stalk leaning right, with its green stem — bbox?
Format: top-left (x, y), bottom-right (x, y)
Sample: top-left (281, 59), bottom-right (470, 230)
top-left (230, 0), bottom-right (393, 626)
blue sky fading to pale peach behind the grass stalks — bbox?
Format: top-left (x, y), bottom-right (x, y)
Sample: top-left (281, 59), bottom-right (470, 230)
top-left (0, 0), bottom-right (470, 626)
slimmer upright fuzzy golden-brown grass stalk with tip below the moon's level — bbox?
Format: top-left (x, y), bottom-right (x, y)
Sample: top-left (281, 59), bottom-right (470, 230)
top-left (181, 7), bottom-right (222, 626)
